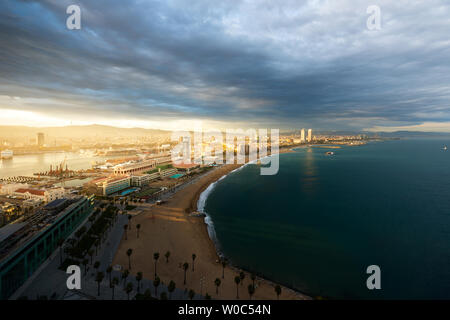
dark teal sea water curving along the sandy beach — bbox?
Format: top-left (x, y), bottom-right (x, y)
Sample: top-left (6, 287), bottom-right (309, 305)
top-left (205, 140), bottom-right (450, 299)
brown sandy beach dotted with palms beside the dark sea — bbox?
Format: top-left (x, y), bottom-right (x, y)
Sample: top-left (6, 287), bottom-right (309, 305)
top-left (113, 151), bottom-right (309, 300)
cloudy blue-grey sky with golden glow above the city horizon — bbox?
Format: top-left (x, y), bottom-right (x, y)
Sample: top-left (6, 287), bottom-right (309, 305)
top-left (0, 0), bottom-right (450, 132)
